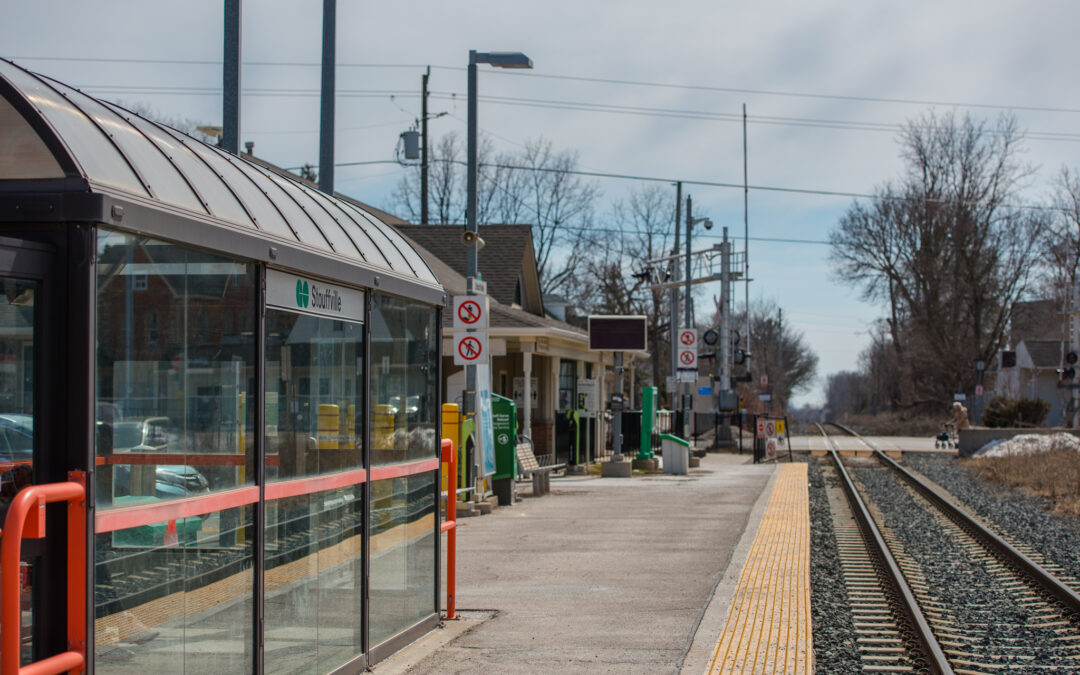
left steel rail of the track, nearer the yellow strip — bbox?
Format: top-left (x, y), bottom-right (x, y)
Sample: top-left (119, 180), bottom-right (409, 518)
top-left (818, 422), bottom-right (954, 675)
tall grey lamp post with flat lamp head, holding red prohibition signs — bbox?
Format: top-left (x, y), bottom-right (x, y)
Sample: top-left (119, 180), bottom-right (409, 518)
top-left (461, 50), bottom-right (532, 425)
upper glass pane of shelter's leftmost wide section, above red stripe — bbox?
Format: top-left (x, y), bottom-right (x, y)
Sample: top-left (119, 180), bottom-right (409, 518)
top-left (96, 230), bottom-right (255, 507)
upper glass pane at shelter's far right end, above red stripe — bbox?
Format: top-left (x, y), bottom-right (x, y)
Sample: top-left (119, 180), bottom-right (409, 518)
top-left (372, 295), bottom-right (440, 465)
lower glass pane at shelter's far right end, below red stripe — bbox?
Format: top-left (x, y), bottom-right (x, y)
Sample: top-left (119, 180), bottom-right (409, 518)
top-left (370, 472), bottom-right (437, 646)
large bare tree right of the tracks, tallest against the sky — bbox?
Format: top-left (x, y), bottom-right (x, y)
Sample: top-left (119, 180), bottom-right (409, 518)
top-left (829, 112), bottom-right (1042, 407)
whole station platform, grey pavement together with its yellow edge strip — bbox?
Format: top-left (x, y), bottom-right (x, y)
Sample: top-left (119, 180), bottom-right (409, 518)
top-left (373, 454), bottom-right (813, 674)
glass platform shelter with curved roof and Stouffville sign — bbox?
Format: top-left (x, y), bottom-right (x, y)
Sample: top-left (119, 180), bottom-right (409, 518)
top-left (0, 62), bottom-right (446, 673)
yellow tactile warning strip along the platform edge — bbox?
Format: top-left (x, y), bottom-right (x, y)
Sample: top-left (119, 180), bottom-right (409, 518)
top-left (707, 463), bottom-right (813, 674)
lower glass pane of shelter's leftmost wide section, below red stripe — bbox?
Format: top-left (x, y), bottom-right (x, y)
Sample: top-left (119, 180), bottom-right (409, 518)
top-left (94, 503), bottom-right (254, 675)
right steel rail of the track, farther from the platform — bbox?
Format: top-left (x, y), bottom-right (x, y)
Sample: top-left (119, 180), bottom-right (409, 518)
top-left (829, 422), bottom-right (1080, 617)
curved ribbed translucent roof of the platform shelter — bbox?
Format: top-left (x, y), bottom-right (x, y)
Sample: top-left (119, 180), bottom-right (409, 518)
top-left (0, 59), bottom-right (438, 295)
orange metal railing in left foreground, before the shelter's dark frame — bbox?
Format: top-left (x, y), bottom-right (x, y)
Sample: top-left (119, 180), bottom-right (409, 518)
top-left (0, 471), bottom-right (86, 675)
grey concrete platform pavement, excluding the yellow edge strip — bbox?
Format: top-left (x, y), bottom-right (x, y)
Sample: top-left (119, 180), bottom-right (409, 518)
top-left (373, 455), bottom-right (778, 673)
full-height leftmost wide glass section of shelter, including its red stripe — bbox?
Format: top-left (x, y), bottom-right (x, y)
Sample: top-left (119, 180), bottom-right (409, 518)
top-left (94, 229), bottom-right (258, 673)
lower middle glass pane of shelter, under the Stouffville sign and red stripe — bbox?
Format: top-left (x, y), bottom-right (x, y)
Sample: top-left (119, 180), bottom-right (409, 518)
top-left (265, 485), bottom-right (364, 673)
